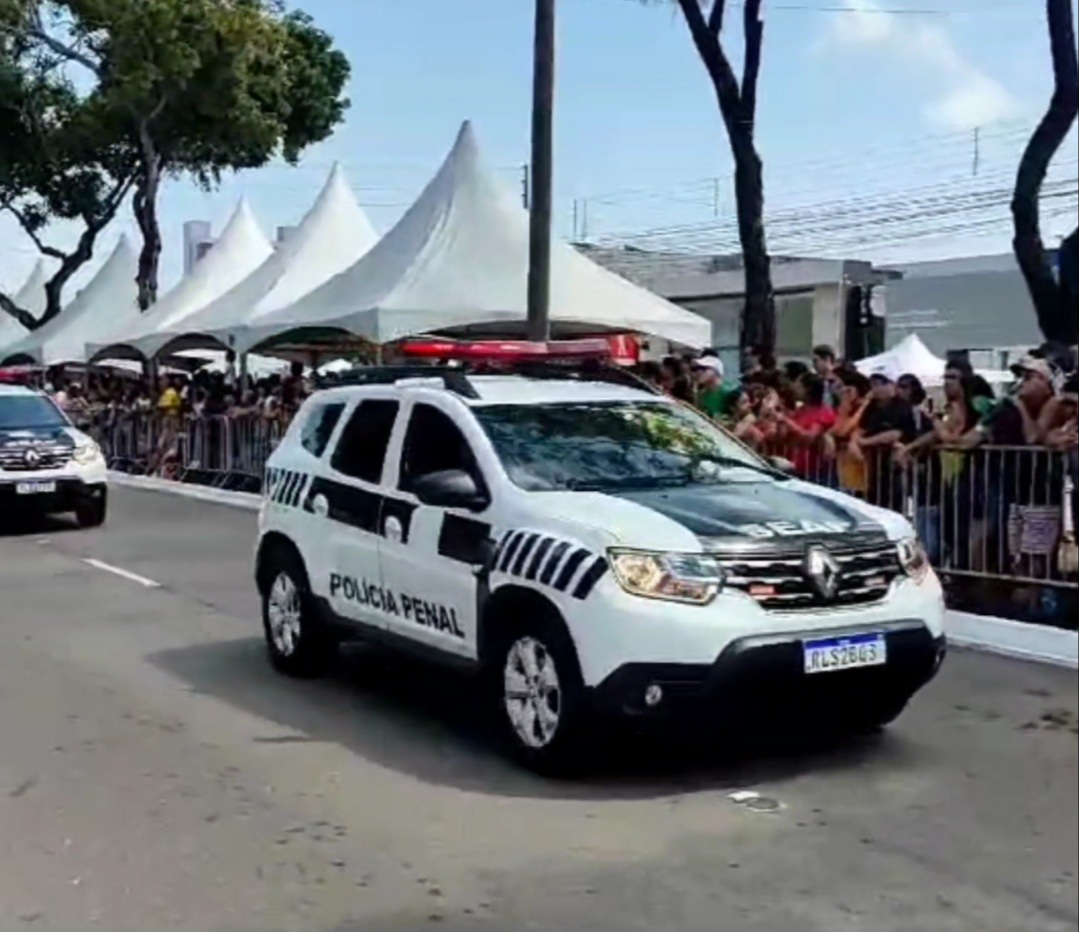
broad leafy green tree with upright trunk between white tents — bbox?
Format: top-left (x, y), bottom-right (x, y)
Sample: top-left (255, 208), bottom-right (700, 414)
top-left (0, 0), bottom-right (350, 310)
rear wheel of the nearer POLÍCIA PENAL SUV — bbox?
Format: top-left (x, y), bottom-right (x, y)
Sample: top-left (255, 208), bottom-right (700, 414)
top-left (260, 548), bottom-right (338, 679)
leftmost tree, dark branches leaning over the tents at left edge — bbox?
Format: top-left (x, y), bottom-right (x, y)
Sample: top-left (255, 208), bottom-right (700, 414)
top-left (0, 9), bottom-right (137, 330)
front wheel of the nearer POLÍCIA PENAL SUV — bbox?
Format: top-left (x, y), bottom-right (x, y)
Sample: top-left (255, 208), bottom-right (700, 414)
top-left (488, 617), bottom-right (590, 777)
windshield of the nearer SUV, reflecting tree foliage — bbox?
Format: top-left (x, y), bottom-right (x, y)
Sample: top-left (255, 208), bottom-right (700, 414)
top-left (474, 401), bottom-right (773, 492)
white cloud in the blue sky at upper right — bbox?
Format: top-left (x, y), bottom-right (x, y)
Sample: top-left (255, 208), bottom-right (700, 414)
top-left (833, 0), bottom-right (1021, 129)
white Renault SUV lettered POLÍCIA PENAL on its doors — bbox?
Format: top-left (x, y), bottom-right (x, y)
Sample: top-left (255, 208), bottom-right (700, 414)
top-left (256, 368), bottom-right (944, 769)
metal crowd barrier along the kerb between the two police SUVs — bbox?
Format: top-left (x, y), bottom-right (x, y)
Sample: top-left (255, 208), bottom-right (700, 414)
top-left (87, 411), bottom-right (287, 492)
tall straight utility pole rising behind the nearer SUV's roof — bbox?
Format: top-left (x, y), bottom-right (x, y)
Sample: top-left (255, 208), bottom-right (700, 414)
top-left (528, 0), bottom-right (555, 341)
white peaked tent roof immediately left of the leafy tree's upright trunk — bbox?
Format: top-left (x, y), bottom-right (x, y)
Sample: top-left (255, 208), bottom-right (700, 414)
top-left (0, 236), bottom-right (139, 366)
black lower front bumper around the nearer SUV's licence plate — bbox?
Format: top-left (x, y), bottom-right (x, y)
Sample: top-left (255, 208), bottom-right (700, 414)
top-left (591, 619), bottom-right (946, 726)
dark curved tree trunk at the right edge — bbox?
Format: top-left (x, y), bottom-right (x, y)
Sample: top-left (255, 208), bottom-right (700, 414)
top-left (1012, 0), bottom-right (1079, 346)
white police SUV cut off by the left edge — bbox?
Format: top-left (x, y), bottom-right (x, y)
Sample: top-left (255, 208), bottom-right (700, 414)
top-left (0, 384), bottom-right (108, 527)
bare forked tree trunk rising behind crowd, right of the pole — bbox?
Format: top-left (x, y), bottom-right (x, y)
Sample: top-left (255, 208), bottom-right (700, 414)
top-left (651, 0), bottom-right (776, 354)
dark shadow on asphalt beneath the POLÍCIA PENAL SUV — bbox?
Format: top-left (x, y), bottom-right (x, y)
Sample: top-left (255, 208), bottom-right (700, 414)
top-left (148, 639), bottom-right (917, 799)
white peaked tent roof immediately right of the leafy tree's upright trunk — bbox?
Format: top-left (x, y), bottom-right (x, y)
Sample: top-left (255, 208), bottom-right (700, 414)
top-left (87, 198), bottom-right (273, 361)
